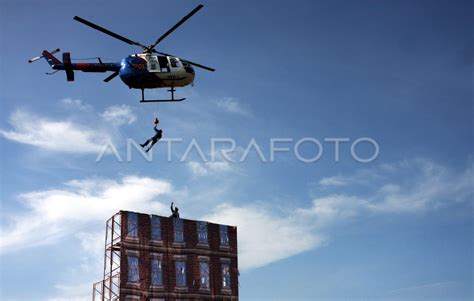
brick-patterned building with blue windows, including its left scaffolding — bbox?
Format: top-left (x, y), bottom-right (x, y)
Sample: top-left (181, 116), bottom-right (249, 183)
top-left (93, 211), bottom-right (239, 301)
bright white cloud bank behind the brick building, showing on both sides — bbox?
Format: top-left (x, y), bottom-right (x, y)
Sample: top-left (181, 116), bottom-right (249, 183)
top-left (0, 171), bottom-right (322, 272)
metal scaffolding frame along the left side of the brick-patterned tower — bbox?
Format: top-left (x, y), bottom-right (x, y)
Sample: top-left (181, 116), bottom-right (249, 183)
top-left (92, 212), bottom-right (122, 301)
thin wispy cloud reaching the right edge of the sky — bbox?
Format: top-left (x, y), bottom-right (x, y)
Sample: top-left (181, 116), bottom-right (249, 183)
top-left (299, 159), bottom-right (474, 220)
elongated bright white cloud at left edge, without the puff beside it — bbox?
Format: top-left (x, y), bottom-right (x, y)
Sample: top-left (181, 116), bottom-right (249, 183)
top-left (0, 110), bottom-right (111, 154)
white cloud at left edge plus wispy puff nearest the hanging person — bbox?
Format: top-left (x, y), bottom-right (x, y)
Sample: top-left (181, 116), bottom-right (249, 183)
top-left (0, 98), bottom-right (136, 154)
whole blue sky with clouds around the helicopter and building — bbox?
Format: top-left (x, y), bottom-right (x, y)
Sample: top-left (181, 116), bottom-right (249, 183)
top-left (0, 0), bottom-right (474, 300)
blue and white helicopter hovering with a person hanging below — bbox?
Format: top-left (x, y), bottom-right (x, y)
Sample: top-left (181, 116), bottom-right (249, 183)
top-left (28, 4), bottom-right (215, 102)
